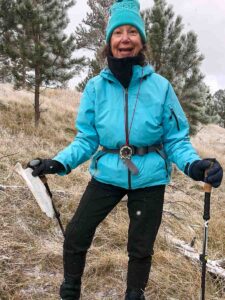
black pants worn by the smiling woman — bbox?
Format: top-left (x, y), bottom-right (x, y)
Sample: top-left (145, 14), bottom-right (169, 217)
top-left (61, 179), bottom-right (165, 299)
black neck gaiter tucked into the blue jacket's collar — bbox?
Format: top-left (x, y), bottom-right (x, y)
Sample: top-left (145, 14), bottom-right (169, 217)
top-left (107, 55), bottom-right (144, 89)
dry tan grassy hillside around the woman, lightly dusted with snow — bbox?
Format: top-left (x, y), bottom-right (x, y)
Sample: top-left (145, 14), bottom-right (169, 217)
top-left (0, 85), bottom-right (225, 300)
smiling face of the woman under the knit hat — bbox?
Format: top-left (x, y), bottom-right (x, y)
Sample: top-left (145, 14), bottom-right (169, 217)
top-left (110, 25), bottom-right (143, 58)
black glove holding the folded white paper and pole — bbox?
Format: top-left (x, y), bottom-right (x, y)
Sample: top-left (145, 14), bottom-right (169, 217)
top-left (27, 158), bottom-right (65, 177)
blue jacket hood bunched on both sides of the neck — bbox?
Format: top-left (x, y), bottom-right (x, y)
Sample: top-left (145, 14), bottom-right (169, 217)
top-left (100, 64), bottom-right (155, 82)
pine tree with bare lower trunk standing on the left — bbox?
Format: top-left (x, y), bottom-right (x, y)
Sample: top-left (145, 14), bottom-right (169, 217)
top-left (0, 0), bottom-right (83, 126)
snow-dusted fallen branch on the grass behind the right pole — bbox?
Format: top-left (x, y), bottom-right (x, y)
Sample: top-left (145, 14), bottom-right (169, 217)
top-left (165, 233), bottom-right (225, 279)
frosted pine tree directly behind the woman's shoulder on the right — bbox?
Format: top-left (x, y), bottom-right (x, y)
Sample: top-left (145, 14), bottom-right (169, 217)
top-left (143, 0), bottom-right (211, 134)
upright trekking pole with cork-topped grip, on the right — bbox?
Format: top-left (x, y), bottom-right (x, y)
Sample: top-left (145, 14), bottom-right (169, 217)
top-left (200, 160), bottom-right (214, 300)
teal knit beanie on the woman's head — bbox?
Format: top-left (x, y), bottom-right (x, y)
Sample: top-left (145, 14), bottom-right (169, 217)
top-left (106, 0), bottom-right (146, 44)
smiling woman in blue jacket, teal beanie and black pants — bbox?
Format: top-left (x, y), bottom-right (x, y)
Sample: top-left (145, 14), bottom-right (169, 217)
top-left (28, 0), bottom-right (223, 300)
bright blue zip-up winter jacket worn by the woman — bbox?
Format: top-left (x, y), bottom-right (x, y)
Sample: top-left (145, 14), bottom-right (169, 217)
top-left (54, 65), bottom-right (200, 189)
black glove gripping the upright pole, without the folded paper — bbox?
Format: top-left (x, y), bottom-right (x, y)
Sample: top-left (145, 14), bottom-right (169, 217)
top-left (184, 158), bottom-right (223, 188)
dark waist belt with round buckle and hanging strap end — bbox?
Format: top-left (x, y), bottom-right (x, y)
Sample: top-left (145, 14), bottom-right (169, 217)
top-left (102, 144), bottom-right (163, 175)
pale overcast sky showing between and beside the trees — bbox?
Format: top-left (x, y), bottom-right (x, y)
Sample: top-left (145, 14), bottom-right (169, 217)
top-left (68, 0), bottom-right (225, 92)
